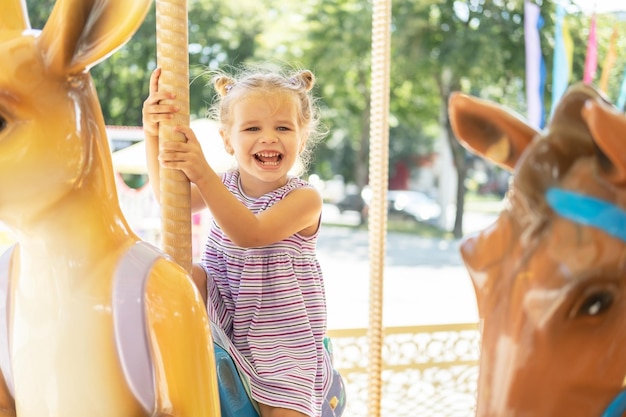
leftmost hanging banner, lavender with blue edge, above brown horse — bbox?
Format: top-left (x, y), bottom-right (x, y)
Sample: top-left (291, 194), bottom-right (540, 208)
top-left (524, 0), bottom-right (546, 128)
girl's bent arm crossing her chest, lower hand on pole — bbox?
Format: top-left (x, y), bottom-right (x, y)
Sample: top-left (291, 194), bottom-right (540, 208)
top-left (161, 126), bottom-right (322, 247)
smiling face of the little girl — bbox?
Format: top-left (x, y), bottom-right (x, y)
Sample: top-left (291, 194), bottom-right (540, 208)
top-left (221, 94), bottom-right (307, 197)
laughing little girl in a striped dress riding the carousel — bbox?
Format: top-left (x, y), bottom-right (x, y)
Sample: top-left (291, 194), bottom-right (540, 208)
top-left (143, 69), bottom-right (331, 417)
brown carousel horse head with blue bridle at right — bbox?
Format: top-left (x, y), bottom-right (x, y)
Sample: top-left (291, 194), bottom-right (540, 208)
top-left (449, 84), bottom-right (626, 417)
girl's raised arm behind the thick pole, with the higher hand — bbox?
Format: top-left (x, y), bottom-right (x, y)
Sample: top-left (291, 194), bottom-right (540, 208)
top-left (142, 68), bottom-right (206, 212)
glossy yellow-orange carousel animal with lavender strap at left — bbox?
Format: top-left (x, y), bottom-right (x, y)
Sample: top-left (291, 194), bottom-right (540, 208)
top-left (0, 0), bottom-right (219, 417)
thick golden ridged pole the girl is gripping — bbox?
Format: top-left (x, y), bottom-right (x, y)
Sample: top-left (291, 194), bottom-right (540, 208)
top-left (156, 0), bottom-right (192, 273)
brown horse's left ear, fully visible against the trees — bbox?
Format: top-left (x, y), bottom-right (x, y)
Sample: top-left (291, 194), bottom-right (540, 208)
top-left (448, 92), bottom-right (539, 171)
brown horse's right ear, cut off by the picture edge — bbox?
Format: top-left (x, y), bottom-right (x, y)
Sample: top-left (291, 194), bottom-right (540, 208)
top-left (582, 100), bottom-right (626, 185)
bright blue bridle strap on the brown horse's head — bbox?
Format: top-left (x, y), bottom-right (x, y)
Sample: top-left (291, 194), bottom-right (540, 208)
top-left (546, 188), bottom-right (626, 417)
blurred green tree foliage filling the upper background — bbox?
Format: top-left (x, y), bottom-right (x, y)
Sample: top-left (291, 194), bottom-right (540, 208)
top-left (22, 0), bottom-right (626, 236)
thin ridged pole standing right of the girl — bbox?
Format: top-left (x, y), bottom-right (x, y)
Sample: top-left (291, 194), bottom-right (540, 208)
top-left (367, 0), bottom-right (391, 417)
